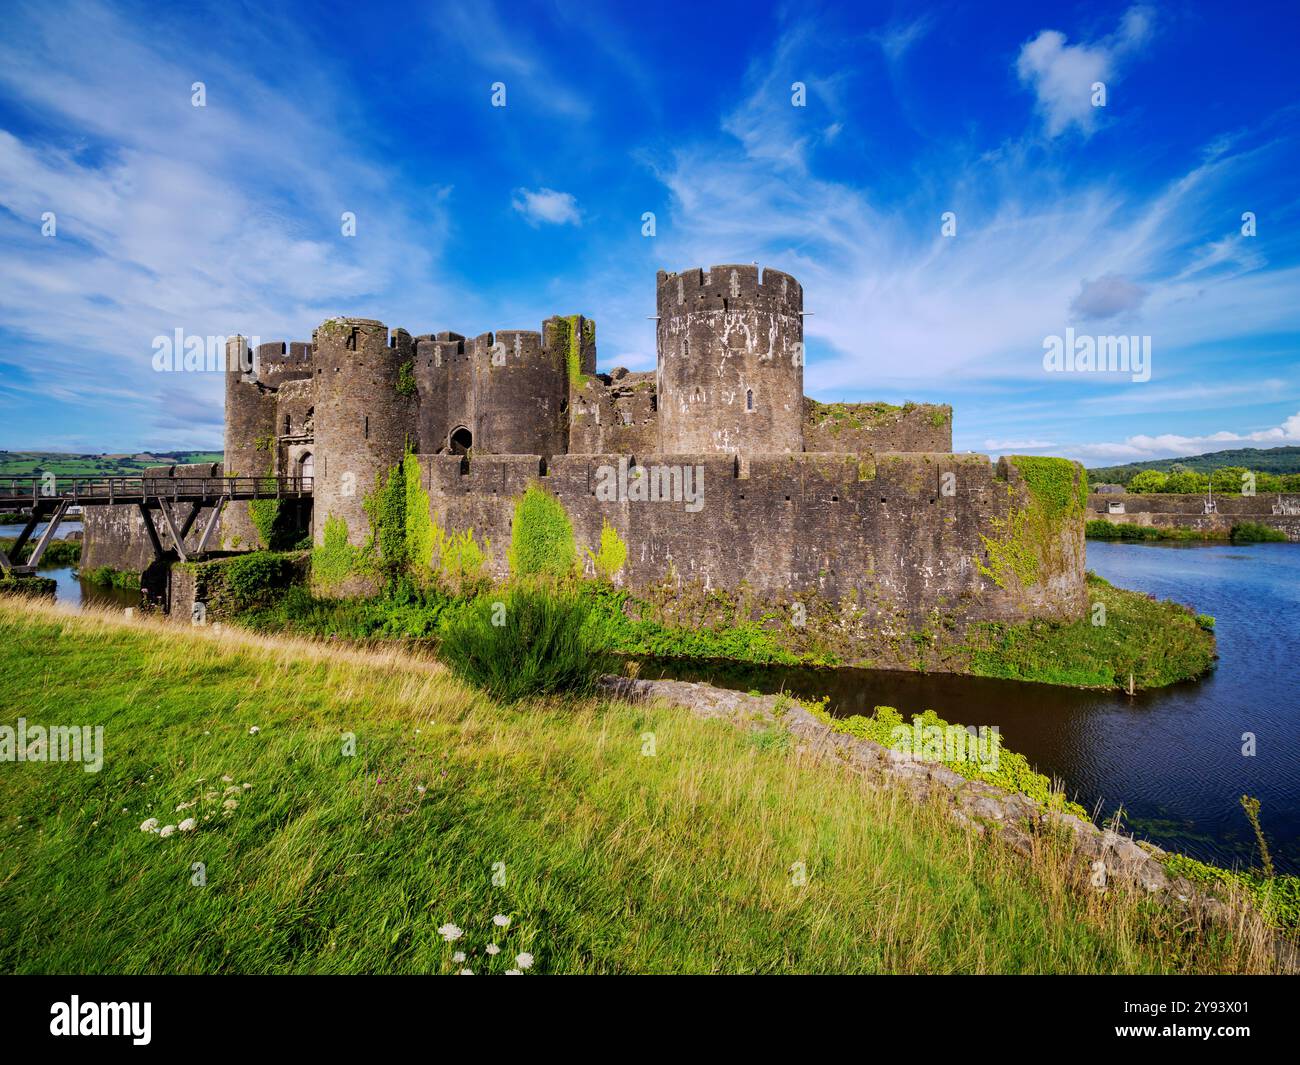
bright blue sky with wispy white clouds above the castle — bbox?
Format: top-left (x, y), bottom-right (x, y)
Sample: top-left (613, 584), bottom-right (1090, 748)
top-left (0, 0), bottom-right (1300, 464)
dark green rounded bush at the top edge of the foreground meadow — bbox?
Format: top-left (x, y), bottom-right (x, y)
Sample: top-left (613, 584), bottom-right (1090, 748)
top-left (439, 586), bottom-right (608, 702)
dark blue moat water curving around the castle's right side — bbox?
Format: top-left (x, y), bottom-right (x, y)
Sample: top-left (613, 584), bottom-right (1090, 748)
top-left (642, 541), bottom-right (1300, 873)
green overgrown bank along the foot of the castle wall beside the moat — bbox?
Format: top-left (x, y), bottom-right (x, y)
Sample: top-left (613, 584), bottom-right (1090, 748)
top-left (228, 573), bottom-right (1216, 688)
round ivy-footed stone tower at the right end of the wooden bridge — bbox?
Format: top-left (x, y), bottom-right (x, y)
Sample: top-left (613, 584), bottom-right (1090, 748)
top-left (312, 319), bottom-right (417, 546)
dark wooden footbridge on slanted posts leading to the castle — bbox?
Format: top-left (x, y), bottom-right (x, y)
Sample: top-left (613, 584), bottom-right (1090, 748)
top-left (0, 473), bottom-right (312, 575)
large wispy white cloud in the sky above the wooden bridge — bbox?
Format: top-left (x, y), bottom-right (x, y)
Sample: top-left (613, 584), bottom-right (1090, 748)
top-left (0, 3), bottom-right (475, 446)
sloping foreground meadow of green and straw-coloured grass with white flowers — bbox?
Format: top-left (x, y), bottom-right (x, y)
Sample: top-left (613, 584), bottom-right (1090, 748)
top-left (0, 601), bottom-right (1271, 973)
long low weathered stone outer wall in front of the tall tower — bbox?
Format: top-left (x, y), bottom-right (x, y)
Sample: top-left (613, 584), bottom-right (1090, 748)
top-left (420, 453), bottom-right (1086, 623)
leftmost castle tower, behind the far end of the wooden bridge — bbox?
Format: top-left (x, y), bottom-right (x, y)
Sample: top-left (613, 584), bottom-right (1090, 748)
top-left (221, 337), bottom-right (312, 550)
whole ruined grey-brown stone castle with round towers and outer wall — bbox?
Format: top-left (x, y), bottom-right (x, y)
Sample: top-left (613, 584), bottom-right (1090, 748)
top-left (88, 265), bottom-right (1086, 631)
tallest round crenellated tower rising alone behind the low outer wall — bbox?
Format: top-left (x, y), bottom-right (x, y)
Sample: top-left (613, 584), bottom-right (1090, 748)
top-left (657, 265), bottom-right (803, 454)
